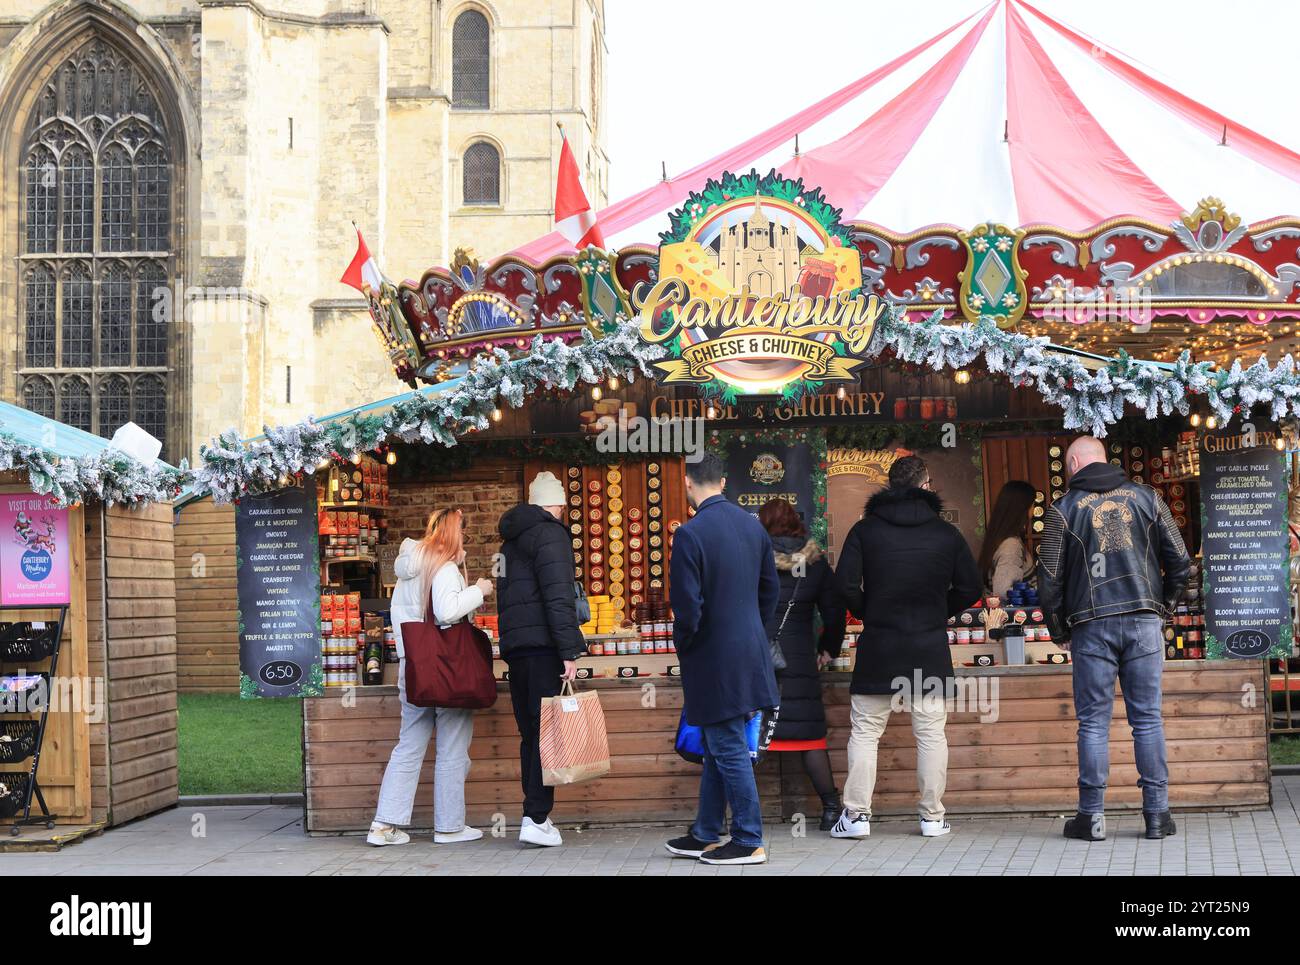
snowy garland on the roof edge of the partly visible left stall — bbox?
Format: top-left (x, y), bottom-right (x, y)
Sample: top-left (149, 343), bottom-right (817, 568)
top-left (0, 430), bottom-right (187, 506)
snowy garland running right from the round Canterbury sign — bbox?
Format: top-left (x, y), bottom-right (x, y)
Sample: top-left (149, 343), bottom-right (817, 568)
top-left (874, 307), bottom-right (1300, 437)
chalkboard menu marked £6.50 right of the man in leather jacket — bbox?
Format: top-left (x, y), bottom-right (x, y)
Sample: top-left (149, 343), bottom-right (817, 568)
top-left (1201, 430), bottom-right (1291, 659)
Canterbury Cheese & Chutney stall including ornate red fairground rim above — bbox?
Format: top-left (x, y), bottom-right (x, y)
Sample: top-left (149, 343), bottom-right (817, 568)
top-left (167, 179), bottom-right (1300, 832)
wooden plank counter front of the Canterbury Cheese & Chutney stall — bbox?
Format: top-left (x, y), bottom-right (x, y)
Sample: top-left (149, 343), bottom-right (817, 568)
top-left (303, 661), bottom-right (1270, 832)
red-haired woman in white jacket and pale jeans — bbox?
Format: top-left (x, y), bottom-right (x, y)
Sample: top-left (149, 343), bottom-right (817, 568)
top-left (365, 510), bottom-right (493, 845)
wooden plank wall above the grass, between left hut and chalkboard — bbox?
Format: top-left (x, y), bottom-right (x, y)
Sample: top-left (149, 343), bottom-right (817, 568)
top-left (174, 499), bottom-right (239, 693)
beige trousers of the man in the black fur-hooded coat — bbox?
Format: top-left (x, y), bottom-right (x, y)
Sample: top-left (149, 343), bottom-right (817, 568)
top-left (844, 693), bottom-right (948, 821)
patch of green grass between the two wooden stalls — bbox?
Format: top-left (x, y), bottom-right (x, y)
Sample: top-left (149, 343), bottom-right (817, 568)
top-left (178, 693), bottom-right (303, 795)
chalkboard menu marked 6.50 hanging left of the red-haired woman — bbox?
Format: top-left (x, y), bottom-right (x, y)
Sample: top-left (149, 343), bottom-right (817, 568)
top-left (235, 476), bottom-right (324, 697)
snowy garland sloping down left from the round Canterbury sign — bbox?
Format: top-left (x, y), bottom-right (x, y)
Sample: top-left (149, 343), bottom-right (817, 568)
top-left (191, 321), bottom-right (664, 502)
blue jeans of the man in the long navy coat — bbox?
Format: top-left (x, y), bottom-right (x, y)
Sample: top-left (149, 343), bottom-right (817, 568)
top-left (690, 717), bottom-right (763, 848)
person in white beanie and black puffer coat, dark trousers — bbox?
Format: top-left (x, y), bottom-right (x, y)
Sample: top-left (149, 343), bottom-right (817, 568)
top-left (497, 472), bottom-right (586, 847)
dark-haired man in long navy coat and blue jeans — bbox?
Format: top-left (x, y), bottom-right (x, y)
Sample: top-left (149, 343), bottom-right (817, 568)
top-left (666, 453), bottom-right (781, 865)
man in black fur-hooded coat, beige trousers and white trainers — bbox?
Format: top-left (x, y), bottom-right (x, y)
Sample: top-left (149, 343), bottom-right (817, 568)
top-left (831, 455), bottom-right (980, 838)
